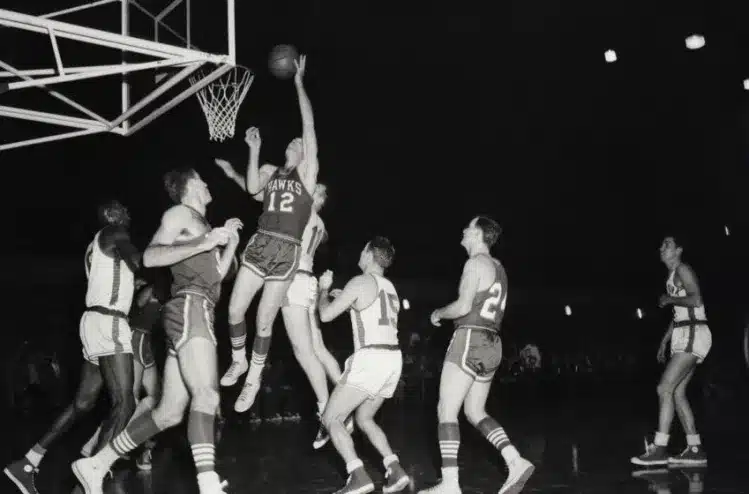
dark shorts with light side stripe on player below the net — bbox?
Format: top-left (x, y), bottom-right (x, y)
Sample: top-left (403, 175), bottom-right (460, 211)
top-left (161, 292), bottom-right (216, 355)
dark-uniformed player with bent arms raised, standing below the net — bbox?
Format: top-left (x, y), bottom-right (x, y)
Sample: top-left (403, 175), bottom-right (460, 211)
top-left (73, 169), bottom-right (242, 494)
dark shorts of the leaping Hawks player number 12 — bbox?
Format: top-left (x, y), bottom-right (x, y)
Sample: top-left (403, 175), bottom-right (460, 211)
top-left (242, 232), bottom-right (301, 281)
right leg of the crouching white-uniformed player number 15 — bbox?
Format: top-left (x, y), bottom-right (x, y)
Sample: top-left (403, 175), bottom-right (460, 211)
top-left (356, 396), bottom-right (411, 494)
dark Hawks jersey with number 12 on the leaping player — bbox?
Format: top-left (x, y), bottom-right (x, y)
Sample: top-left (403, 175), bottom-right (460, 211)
top-left (257, 168), bottom-right (312, 243)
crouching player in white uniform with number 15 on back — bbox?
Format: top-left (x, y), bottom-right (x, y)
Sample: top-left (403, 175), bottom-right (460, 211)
top-left (319, 237), bottom-right (411, 494)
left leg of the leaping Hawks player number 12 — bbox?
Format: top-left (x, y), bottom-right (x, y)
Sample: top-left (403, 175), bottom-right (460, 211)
top-left (221, 264), bottom-right (264, 386)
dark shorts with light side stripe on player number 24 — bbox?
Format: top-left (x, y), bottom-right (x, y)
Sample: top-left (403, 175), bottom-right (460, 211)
top-left (445, 328), bottom-right (502, 382)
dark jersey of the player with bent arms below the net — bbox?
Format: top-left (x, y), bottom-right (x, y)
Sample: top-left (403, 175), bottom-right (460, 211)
top-left (170, 211), bottom-right (221, 303)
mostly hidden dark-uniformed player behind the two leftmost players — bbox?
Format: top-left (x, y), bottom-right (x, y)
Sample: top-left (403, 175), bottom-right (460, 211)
top-left (81, 279), bottom-right (163, 470)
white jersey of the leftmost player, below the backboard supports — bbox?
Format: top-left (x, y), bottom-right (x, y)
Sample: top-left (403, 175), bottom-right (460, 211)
top-left (86, 230), bottom-right (135, 314)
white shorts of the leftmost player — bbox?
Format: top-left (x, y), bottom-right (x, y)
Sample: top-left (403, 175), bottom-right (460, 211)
top-left (80, 311), bottom-right (133, 365)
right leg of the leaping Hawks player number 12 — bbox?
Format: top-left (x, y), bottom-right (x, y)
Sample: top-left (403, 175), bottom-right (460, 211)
top-left (234, 276), bottom-right (291, 413)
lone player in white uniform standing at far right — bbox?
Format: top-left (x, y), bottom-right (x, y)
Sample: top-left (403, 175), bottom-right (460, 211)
top-left (632, 237), bottom-right (713, 466)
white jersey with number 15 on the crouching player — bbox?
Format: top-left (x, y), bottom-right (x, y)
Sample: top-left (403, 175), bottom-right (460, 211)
top-left (350, 274), bottom-right (400, 351)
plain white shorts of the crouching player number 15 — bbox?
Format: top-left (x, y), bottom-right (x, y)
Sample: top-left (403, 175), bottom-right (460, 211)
top-left (340, 345), bottom-right (403, 399)
